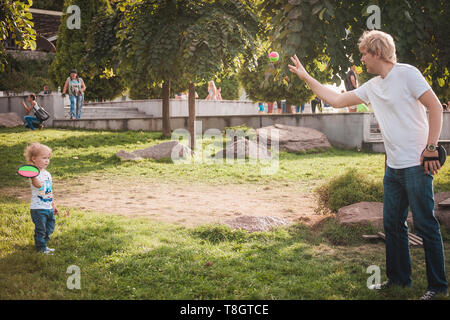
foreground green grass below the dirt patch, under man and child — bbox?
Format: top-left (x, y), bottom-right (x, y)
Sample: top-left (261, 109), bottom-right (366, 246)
top-left (0, 197), bottom-right (450, 299)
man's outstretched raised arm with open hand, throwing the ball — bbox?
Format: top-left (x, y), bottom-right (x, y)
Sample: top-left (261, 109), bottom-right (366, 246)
top-left (289, 55), bottom-right (364, 108)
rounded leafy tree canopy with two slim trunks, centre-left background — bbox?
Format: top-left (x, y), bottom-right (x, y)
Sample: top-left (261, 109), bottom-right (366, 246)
top-left (91, 0), bottom-right (257, 142)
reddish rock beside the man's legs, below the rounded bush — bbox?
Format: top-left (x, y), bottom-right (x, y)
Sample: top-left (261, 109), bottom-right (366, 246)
top-left (336, 202), bottom-right (412, 228)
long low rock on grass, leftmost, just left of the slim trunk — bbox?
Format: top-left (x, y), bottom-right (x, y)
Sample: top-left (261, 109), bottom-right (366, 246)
top-left (116, 141), bottom-right (190, 160)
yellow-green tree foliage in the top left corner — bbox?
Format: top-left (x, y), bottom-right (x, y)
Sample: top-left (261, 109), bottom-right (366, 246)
top-left (0, 0), bottom-right (36, 72)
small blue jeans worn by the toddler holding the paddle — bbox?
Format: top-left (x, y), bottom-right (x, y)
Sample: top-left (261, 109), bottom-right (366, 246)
top-left (30, 209), bottom-right (55, 252)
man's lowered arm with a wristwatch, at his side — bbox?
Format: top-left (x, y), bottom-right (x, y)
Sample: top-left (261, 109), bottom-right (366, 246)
top-left (419, 89), bottom-right (442, 174)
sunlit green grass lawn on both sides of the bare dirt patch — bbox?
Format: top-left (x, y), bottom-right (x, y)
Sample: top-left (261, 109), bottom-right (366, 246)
top-left (0, 128), bottom-right (450, 299)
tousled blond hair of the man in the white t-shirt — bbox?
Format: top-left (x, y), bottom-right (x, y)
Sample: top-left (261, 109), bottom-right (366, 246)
top-left (358, 30), bottom-right (397, 63)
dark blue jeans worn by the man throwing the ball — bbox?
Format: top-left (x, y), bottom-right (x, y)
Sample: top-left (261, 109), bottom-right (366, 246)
top-left (383, 166), bottom-right (448, 292)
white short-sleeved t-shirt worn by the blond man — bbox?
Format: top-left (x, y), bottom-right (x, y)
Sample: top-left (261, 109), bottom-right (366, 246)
top-left (353, 63), bottom-right (431, 169)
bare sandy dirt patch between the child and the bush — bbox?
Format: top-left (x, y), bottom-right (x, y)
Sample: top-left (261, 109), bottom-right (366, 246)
top-left (2, 177), bottom-right (324, 227)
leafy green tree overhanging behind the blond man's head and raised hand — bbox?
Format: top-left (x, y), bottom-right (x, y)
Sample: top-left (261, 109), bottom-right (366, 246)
top-left (261, 0), bottom-right (450, 98)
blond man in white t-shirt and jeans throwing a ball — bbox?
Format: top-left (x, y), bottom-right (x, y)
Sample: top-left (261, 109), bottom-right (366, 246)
top-left (289, 30), bottom-right (448, 300)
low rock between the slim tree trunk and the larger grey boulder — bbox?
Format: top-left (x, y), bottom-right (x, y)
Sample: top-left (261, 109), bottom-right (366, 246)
top-left (213, 137), bottom-right (272, 160)
